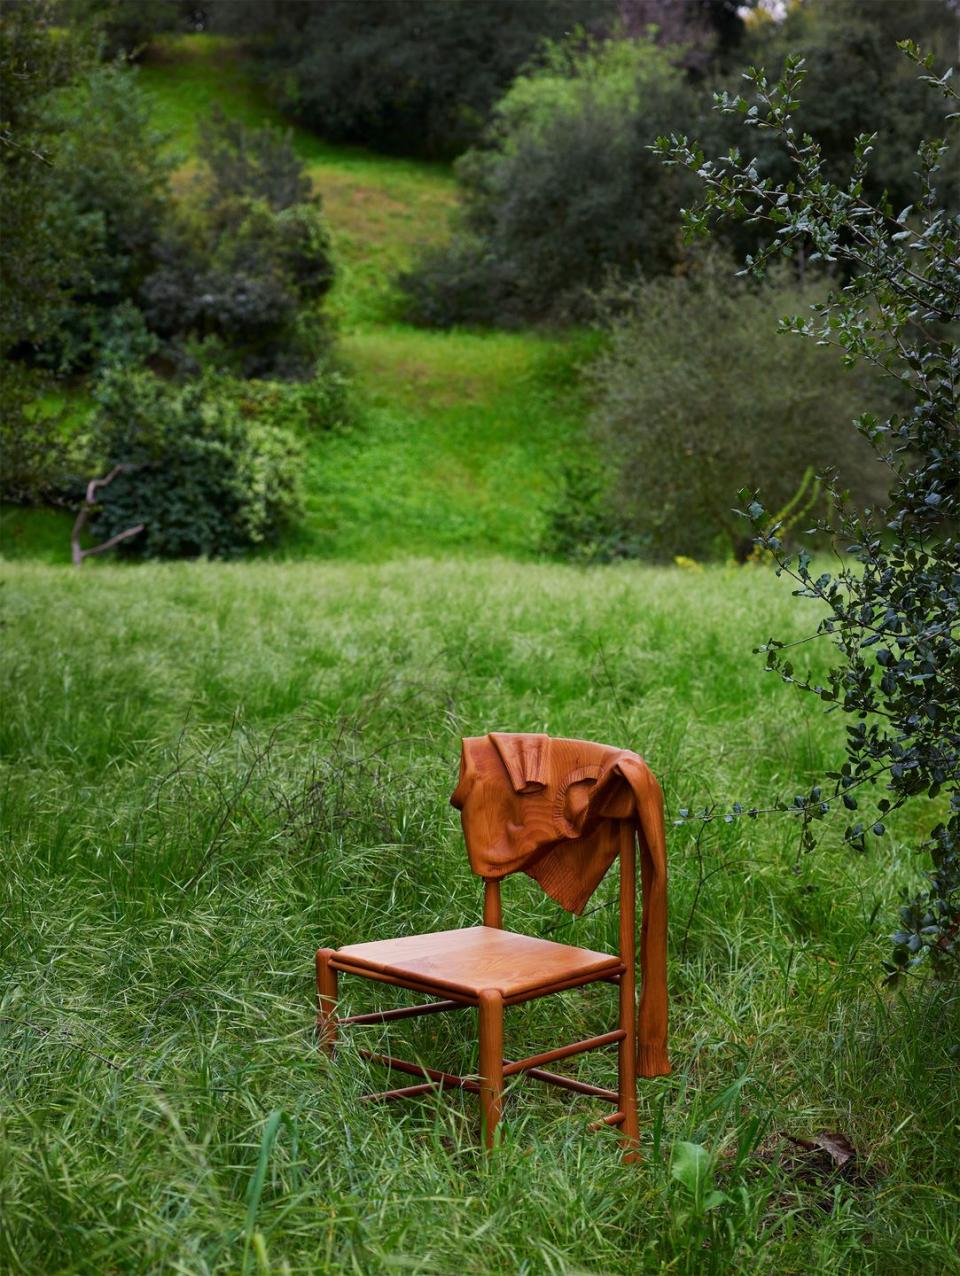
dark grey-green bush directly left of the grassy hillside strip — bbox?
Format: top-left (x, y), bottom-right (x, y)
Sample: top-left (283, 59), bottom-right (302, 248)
top-left (140, 116), bottom-right (333, 376)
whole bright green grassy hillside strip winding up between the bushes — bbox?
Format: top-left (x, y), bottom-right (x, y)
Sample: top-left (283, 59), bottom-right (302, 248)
top-left (142, 36), bottom-right (590, 559)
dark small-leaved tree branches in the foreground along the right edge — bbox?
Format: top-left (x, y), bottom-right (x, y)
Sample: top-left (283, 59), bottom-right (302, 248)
top-left (657, 41), bottom-right (960, 977)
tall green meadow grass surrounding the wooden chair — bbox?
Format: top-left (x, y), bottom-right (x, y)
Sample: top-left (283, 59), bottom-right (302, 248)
top-left (0, 559), bottom-right (960, 1276)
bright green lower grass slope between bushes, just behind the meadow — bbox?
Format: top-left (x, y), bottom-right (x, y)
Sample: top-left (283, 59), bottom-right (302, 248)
top-left (289, 327), bottom-right (597, 559)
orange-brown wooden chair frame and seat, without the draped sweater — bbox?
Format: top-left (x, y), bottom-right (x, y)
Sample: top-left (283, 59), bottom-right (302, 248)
top-left (317, 820), bottom-right (638, 1148)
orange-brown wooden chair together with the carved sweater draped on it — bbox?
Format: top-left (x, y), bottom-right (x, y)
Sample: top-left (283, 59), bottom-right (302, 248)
top-left (317, 735), bottom-right (669, 1160)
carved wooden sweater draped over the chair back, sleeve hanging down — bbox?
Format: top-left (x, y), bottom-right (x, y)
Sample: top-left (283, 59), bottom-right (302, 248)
top-left (451, 731), bottom-right (670, 1077)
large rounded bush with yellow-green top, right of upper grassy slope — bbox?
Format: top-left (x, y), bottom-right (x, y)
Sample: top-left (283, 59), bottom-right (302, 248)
top-left (401, 41), bottom-right (693, 325)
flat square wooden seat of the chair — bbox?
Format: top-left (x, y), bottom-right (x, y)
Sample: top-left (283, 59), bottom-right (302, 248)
top-left (333, 926), bottom-right (623, 998)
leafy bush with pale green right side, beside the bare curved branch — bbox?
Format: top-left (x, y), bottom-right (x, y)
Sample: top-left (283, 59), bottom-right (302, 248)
top-left (85, 371), bottom-right (303, 558)
